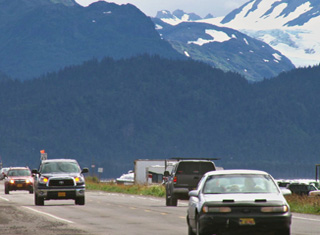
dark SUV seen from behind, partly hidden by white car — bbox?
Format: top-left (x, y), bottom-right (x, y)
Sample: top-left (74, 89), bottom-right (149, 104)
top-left (164, 159), bottom-right (216, 206)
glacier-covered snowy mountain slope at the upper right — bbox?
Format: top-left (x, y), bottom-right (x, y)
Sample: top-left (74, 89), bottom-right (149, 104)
top-left (214, 0), bottom-right (320, 67)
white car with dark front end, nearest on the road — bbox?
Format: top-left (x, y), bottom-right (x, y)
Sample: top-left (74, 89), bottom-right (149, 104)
top-left (187, 170), bottom-right (292, 235)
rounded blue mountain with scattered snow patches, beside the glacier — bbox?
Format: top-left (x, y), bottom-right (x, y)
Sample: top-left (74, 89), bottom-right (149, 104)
top-left (153, 11), bottom-right (294, 81)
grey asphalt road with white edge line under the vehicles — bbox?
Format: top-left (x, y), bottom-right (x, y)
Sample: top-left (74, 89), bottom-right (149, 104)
top-left (0, 182), bottom-right (320, 235)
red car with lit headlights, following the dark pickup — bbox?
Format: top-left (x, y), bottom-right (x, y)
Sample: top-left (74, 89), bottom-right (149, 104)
top-left (4, 167), bottom-right (33, 194)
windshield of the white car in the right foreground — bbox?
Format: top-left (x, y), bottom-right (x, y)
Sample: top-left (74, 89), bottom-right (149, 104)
top-left (203, 174), bottom-right (279, 194)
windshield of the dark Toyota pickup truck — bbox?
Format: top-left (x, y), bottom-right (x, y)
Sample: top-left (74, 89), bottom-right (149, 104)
top-left (40, 162), bottom-right (80, 173)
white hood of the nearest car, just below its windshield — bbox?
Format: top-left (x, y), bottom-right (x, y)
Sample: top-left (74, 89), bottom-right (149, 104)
top-left (204, 193), bottom-right (285, 203)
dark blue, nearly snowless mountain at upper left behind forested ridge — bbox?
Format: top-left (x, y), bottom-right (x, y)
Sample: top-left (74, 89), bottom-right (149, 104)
top-left (0, 0), bottom-right (184, 80)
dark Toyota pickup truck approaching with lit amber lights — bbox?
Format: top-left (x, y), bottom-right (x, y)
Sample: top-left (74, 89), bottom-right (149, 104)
top-left (32, 159), bottom-right (89, 206)
